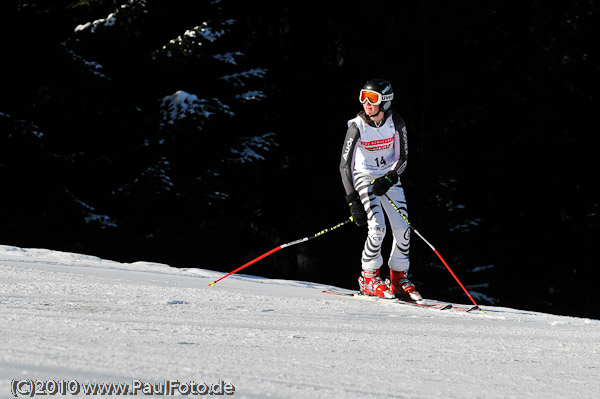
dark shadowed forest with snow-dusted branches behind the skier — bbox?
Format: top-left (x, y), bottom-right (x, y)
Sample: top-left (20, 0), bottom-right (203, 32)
top-left (0, 0), bottom-right (600, 318)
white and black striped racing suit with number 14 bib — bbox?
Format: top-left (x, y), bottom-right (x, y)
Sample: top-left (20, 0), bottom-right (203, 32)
top-left (340, 111), bottom-right (410, 271)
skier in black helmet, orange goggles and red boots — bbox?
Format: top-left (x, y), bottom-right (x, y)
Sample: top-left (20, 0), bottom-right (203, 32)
top-left (340, 79), bottom-right (423, 301)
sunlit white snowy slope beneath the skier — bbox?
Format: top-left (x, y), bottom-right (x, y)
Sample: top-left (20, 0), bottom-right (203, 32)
top-left (0, 246), bottom-right (600, 399)
